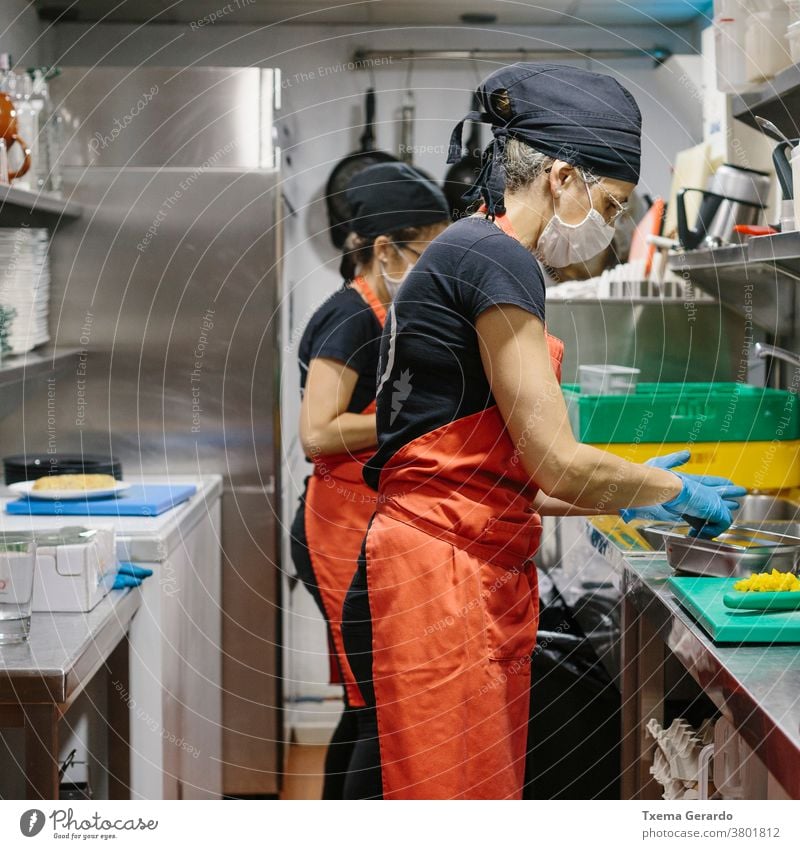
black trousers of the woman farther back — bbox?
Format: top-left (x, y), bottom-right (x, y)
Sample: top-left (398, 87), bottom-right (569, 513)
top-left (291, 486), bottom-right (374, 799)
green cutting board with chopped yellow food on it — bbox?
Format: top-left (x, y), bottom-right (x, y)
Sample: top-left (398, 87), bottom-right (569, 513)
top-left (667, 577), bottom-right (800, 643)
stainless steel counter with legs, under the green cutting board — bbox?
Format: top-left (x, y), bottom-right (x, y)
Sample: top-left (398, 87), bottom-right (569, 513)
top-left (549, 519), bottom-right (800, 799)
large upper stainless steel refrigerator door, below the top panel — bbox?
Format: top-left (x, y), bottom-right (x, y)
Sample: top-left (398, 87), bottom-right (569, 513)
top-left (26, 168), bottom-right (279, 487)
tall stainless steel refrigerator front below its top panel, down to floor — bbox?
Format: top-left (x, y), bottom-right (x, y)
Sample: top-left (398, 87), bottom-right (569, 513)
top-left (0, 168), bottom-right (281, 795)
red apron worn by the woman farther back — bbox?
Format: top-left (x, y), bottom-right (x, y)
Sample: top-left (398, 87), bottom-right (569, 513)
top-left (305, 277), bottom-right (386, 707)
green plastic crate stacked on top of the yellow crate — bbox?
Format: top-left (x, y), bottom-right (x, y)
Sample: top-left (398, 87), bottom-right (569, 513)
top-left (562, 383), bottom-right (800, 443)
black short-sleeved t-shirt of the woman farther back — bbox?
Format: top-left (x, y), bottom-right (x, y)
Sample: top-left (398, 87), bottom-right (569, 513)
top-left (297, 286), bottom-right (381, 413)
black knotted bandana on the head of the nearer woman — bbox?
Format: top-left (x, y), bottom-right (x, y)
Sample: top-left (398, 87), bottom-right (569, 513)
top-left (447, 62), bottom-right (642, 216)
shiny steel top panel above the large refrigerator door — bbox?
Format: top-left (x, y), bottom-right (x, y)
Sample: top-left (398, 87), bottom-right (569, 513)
top-left (50, 67), bottom-right (279, 168)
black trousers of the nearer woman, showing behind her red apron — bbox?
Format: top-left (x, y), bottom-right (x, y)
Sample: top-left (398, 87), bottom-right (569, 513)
top-left (342, 529), bottom-right (383, 799)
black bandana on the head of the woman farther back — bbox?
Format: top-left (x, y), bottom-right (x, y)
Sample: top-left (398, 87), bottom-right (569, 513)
top-left (346, 162), bottom-right (450, 238)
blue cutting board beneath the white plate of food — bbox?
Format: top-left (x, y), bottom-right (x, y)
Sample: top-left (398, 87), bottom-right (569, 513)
top-left (6, 484), bottom-right (197, 516)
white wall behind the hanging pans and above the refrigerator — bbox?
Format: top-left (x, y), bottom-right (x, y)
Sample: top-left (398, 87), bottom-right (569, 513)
top-left (40, 18), bottom-right (700, 716)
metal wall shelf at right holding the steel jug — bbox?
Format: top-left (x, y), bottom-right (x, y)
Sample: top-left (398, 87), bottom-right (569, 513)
top-left (668, 237), bottom-right (800, 336)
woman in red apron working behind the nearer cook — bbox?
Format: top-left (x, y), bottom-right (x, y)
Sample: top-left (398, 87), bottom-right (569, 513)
top-left (292, 163), bottom-right (448, 799)
